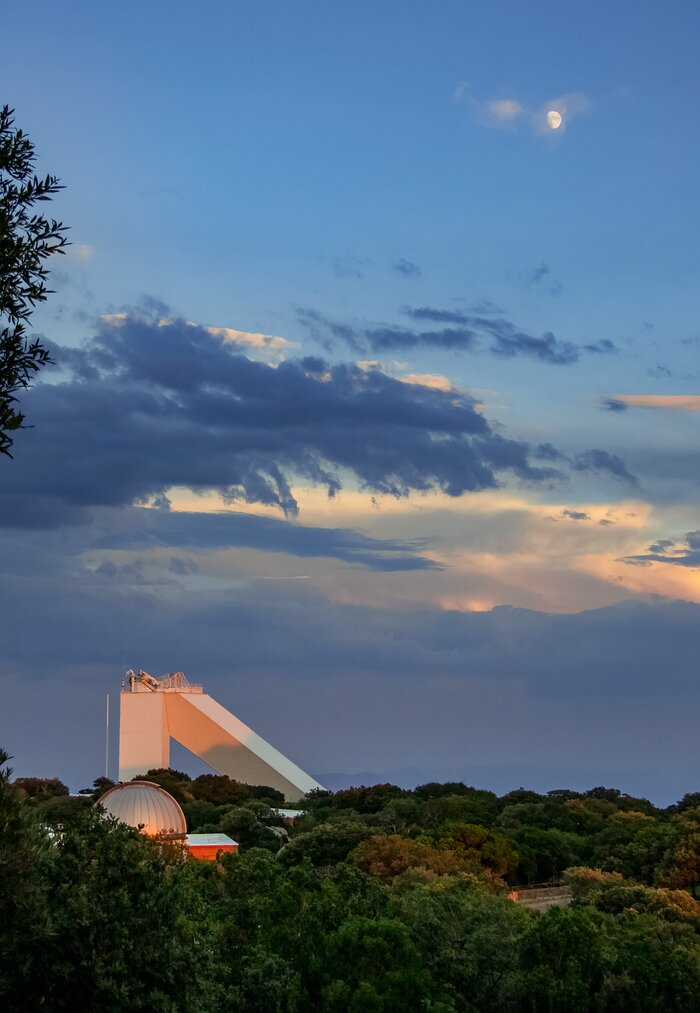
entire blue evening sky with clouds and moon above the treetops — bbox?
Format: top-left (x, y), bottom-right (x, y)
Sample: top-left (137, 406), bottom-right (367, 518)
top-left (0, 0), bottom-right (700, 803)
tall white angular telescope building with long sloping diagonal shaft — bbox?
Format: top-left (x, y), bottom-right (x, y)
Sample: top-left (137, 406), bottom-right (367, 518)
top-left (120, 669), bottom-right (323, 802)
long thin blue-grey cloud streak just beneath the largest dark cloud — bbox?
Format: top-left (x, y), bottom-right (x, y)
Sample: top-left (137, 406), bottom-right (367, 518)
top-left (92, 508), bottom-right (442, 575)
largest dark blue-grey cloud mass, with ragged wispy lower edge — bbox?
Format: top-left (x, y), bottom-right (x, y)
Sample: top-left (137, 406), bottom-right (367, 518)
top-left (0, 316), bottom-right (558, 527)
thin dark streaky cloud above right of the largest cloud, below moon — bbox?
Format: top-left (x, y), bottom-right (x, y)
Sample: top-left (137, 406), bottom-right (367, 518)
top-left (299, 306), bottom-right (617, 366)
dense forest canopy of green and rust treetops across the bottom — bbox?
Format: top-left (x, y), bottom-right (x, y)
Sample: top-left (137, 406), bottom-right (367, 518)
top-left (0, 755), bottom-right (700, 1013)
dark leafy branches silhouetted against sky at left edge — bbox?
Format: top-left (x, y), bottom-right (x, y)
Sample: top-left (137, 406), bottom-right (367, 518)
top-left (0, 105), bottom-right (68, 457)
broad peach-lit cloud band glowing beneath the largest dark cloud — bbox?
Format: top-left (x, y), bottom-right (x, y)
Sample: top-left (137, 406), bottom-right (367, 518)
top-left (166, 487), bottom-right (680, 612)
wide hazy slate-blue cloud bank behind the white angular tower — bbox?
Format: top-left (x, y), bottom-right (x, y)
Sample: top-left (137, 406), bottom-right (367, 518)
top-left (0, 559), bottom-right (700, 801)
